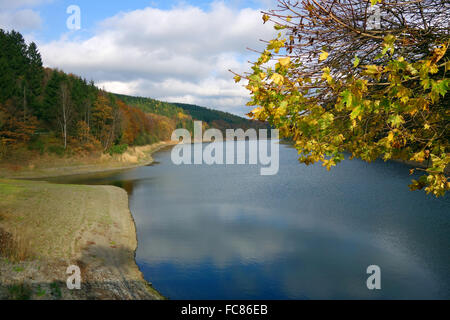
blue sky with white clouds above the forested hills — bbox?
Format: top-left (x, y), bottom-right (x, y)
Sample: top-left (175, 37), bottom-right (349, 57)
top-left (0, 0), bottom-right (276, 116)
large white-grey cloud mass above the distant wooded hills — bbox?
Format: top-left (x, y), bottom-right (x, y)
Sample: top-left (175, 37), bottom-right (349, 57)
top-left (40, 2), bottom-right (274, 114)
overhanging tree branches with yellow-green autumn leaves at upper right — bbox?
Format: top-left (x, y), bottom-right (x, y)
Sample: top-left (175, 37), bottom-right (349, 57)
top-left (235, 0), bottom-right (450, 196)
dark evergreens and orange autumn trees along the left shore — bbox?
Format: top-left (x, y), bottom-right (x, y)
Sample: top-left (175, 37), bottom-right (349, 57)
top-left (0, 29), bottom-right (192, 159)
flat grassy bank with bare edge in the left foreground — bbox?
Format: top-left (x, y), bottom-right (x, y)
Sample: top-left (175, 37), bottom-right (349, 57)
top-left (0, 179), bottom-right (162, 299)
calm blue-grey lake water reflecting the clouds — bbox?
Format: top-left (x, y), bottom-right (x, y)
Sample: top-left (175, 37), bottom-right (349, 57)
top-left (50, 142), bottom-right (450, 299)
